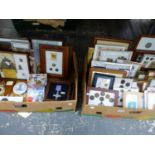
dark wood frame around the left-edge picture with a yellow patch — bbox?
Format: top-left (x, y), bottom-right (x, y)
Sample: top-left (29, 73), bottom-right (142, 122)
top-left (0, 50), bottom-right (31, 80)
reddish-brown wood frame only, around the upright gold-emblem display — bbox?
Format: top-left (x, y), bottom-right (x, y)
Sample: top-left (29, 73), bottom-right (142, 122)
top-left (40, 45), bottom-right (69, 78)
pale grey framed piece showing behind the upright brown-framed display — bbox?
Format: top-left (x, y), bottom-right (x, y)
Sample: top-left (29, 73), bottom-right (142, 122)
top-left (31, 39), bottom-right (63, 65)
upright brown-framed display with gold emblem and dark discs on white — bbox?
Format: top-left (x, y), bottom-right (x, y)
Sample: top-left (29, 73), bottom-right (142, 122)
top-left (40, 45), bottom-right (69, 78)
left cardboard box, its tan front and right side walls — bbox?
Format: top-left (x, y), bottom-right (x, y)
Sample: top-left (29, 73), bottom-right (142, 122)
top-left (0, 52), bottom-right (78, 112)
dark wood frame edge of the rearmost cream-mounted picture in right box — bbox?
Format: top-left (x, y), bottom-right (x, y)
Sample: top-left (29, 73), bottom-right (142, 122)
top-left (94, 36), bottom-right (133, 50)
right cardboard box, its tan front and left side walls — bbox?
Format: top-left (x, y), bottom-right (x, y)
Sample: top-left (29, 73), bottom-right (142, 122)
top-left (81, 57), bottom-right (155, 120)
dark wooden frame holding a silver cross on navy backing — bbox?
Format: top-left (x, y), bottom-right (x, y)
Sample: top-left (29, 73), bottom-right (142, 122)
top-left (45, 79), bottom-right (71, 101)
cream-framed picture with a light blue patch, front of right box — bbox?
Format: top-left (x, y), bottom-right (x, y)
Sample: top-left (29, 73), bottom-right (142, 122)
top-left (123, 92), bottom-right (144, 109)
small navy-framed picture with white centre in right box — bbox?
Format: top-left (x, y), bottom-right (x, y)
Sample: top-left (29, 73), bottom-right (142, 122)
top-left (92, 73), bottom-right (115, 89)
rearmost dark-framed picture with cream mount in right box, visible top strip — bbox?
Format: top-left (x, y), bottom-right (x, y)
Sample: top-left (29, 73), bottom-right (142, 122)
top-left (94, 37), bottom-right (132, 50)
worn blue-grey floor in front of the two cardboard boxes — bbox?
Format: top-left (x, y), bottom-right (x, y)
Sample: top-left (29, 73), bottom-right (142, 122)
top-left (0, 112), bottom-right (155, 135)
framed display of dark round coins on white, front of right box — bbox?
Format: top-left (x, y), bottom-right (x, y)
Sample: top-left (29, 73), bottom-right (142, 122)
top-left (87, 87), bottom-right (118, 107)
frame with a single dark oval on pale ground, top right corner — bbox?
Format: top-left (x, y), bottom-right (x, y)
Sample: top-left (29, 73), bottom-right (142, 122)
top-left (136, 35), bottom-right (155, 53)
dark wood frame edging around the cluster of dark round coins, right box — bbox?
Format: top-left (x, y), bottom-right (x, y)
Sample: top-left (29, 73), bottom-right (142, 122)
top-left (86, 87), bottom-right (119, 107)
